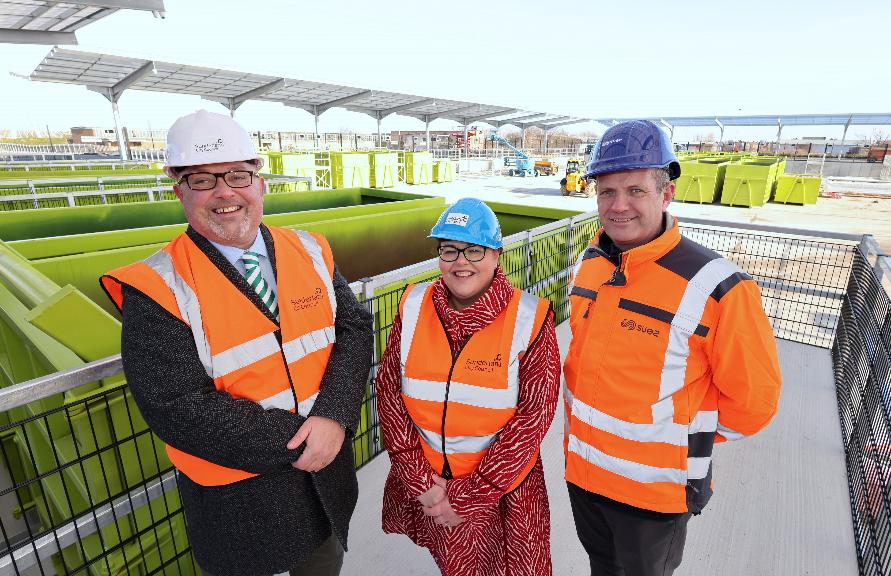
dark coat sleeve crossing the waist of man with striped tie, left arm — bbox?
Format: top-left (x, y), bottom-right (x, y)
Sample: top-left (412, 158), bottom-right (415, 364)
top-left (121, 286), bottom-right (304, 474)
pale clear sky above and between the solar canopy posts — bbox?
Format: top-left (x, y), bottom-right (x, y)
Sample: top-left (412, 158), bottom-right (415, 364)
top-left (0, 0), bottom-right (891, 140)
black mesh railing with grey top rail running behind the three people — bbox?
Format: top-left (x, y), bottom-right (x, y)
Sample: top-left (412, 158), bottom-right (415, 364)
top-left (0, 213), bottom-right (876, 576)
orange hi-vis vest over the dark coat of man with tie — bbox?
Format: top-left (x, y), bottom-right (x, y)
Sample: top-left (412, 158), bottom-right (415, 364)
top-left (101, 227), bottom-right (337, 486)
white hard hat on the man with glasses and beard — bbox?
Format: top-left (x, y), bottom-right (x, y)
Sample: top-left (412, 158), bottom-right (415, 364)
top-left (165, 110), bottom-right (260, 169)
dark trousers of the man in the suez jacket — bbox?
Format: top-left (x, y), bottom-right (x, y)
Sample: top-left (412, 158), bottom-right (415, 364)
top-left (567, 482), bottom-right (690, 576)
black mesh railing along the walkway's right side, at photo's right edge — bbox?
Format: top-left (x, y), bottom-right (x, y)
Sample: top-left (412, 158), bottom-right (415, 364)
top-left (832, 237), bottom-right (891, 576)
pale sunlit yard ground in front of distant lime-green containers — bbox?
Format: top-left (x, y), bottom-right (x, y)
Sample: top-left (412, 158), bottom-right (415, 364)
top-left (396, 172), bottom-right (891, 254)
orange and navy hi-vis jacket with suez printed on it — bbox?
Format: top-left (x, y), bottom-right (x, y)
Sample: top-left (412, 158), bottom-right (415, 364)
top-left (564, 216), bottom-right (781, 513)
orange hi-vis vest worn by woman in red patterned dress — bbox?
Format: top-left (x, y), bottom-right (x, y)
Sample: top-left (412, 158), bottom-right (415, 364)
top-left (399, 283), bottom-right (550, 492)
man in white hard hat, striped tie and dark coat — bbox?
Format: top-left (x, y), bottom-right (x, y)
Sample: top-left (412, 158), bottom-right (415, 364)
top-left (102, 110), bottom-right (372, 576)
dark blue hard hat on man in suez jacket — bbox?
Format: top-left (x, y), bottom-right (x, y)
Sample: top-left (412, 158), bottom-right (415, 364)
top-left (585, 120), bottom-right (681, 180)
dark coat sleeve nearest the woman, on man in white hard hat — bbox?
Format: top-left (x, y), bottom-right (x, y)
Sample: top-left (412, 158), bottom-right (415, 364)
top-left (309, 266), bottom-right (374, 435)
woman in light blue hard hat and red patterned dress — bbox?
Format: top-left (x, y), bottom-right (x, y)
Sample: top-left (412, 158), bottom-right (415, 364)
top-left (376, 198), bottom-right (560, 576)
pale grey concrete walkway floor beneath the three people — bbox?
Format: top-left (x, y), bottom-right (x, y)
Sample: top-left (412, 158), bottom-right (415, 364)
top-left (342, 323), bottom-right (857, 576)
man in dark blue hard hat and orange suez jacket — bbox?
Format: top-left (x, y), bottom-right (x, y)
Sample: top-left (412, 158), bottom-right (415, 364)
top-left (564, 120), bottom-right (780, 576)
